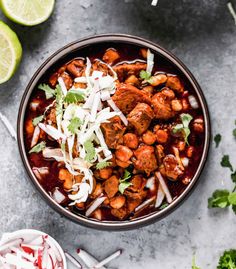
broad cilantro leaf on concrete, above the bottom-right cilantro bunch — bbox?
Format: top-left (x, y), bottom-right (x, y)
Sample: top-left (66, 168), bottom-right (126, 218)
top-left (208, 190), bottom-right (230, 208)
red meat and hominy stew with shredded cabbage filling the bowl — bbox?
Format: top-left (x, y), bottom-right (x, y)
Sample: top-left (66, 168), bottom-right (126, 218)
top-left (24, 44), bottom-right (205, 221)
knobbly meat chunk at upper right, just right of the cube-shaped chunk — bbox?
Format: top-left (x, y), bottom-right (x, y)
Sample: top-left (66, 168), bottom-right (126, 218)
top-left (152, 88), bottom-right (176, 120)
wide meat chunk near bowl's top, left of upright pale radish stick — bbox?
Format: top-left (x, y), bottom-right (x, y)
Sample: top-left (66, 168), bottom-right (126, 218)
top-left (113, 61), bottom-right (147, 81)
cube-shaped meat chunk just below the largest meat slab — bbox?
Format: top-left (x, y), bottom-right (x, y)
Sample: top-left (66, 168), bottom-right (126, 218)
top-left (127, 103), bottom-right (154, 135)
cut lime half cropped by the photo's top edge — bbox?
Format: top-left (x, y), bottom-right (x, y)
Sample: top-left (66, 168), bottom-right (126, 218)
top-left (0, 0), bottom-right (55, 26)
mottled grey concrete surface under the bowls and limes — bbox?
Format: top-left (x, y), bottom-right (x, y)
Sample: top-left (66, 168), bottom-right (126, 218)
top-left (0, 0), bottom-right (236, 269)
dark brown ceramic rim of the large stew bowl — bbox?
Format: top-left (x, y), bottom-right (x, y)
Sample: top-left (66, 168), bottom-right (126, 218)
top-left (17, 33), bottom-right (211, 231)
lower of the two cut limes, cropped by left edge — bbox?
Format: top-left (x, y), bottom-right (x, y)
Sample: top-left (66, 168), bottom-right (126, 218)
top-left (0, 21), bottom-right (22, 84)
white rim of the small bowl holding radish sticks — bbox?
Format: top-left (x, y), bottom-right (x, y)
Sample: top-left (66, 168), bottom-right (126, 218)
top-left (0, 229), bottom-right (67, 269)
